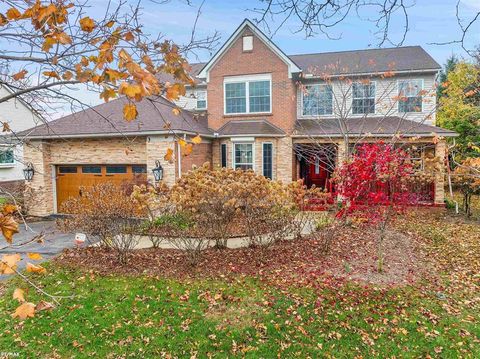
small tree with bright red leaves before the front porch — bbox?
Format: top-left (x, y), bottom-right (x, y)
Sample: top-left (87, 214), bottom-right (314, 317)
top-left (334, 142), bottom-right (418, 272)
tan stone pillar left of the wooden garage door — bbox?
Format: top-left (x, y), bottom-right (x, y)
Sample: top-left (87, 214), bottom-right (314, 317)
top-left (23, 141), bottom-right (55, 217)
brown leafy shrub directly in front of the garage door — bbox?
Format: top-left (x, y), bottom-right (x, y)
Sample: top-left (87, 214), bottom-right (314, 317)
top-left (58, 183), bottom-right (146, 263)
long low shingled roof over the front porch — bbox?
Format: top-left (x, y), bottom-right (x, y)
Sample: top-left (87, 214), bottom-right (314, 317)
top-left (293, 116), bottom-right (457, 137)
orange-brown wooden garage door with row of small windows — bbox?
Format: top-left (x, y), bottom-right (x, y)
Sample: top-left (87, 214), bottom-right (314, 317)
top-left (56, 164), bottom-right (147, 212)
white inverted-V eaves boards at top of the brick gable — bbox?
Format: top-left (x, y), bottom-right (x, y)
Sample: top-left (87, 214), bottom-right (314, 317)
top-left (197, 19), bottom-right (302, 82)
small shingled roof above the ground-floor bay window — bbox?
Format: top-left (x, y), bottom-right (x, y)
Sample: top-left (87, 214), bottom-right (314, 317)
top-left (216, 120), bottom-right (285, 137)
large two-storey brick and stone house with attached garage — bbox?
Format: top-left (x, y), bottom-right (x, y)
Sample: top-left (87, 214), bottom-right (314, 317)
top-left (25, 20), bottom-right (455, 215)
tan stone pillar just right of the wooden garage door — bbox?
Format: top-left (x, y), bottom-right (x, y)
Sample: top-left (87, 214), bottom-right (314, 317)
top-left (146, 136), bottom-right (178, 186)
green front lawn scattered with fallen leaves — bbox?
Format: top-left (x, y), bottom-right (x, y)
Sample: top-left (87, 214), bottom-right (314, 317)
top-left (0, 267), bottom-right (480, 358)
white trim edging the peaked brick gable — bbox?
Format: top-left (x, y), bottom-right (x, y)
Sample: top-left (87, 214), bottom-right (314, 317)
top-left (198, 19), bottom-right (301, 82)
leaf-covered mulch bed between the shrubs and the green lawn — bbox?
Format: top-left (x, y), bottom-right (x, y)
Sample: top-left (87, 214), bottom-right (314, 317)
top-left (55, 228), bottom-right (424, 286)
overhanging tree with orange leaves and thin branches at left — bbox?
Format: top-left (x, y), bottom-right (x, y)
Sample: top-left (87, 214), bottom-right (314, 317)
top-left (0, 0), bottom-right (218, 319)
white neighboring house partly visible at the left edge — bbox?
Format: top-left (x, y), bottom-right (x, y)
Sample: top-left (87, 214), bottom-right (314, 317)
top-left (0, 85), bottom-right (41, 192)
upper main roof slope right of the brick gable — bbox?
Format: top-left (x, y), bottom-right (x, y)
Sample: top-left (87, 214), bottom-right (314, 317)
top-left (289, 46), bottom-right (441, 75)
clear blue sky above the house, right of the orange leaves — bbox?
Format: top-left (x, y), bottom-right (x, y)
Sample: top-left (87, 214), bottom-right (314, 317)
top-left (127, 0), bottom-right (480, 64)
